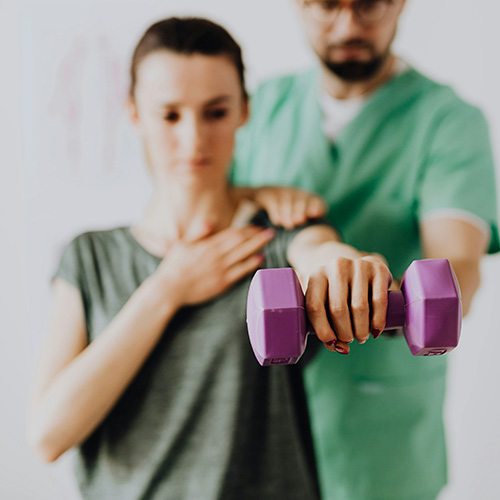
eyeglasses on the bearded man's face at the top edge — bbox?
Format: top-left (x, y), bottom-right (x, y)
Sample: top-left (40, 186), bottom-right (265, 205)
top-left (303, 0), bottom-right (396, 25)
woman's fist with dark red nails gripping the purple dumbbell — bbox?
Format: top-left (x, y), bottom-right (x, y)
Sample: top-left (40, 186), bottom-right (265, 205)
top-left (305, 254), bottom-right (392, 354)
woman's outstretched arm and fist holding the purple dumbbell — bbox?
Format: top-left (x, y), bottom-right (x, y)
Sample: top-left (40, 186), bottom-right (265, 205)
top-left (287, 225), bottom-right (392, 354)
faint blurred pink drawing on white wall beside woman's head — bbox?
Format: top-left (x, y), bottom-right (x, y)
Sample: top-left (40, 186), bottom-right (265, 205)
top-left (47, 33), bottom-right (128, 177)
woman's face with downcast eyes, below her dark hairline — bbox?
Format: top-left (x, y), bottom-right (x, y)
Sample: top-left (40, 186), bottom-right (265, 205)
top-left (129, 50), bottom-right (248, 185)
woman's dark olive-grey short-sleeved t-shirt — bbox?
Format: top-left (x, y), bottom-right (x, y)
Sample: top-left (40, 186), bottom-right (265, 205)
top-left (55, 216), bottom-right (318, 500)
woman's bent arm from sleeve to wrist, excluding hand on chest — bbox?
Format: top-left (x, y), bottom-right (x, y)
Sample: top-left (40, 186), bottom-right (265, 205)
top-left (28, 275), bottom-right (177, 462)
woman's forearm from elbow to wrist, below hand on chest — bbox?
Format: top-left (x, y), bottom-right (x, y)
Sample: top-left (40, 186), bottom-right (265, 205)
top-left (32, 275), bottom-right (178, 462)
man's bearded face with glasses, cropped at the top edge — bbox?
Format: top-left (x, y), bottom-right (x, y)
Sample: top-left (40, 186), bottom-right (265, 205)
top-left (296, 0), bottom-right (405, 82)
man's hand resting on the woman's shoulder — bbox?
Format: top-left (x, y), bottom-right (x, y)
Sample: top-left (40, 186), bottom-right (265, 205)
top-left (236, 186), bottom-right (328, 229)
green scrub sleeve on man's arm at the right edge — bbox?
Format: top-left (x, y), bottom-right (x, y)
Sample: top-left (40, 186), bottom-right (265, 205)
top-left (418, 102), bottom-right (500, 253)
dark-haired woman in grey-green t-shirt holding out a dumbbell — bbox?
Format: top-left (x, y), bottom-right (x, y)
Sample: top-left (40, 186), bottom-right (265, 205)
top-left (30, 18), bottom-right (391, 500)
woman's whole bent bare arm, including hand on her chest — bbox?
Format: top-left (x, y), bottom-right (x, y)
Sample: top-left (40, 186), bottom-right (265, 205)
top-left (28, 227), bottom-right (272, 462)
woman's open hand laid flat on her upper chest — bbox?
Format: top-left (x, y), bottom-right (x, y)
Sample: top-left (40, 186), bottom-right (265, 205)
top-left (156, 226), bottom-right (274, 307)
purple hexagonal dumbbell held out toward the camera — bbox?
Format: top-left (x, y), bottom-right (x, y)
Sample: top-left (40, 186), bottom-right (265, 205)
top-left (247, 259), bottom-right (462, 366)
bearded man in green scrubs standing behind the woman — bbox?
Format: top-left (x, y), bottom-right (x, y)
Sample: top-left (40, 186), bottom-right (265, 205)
top-left (233, 0), bottom-right (500, 500)
